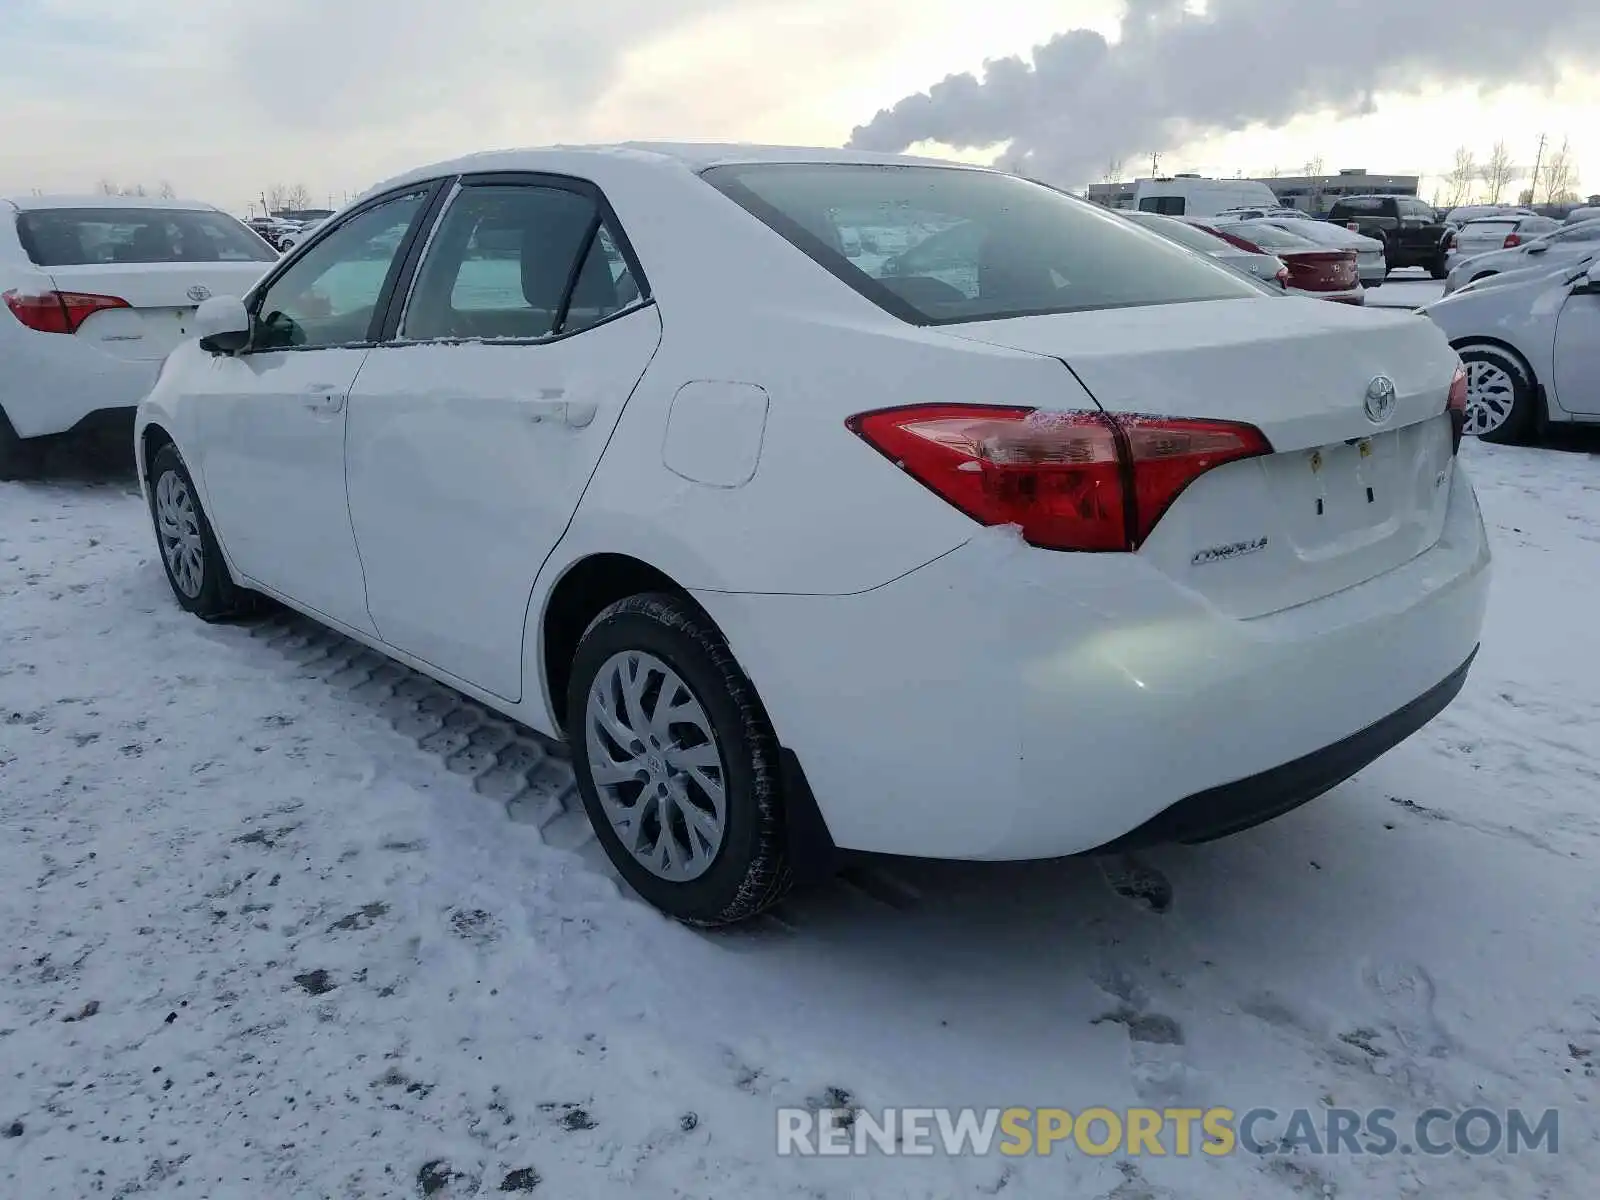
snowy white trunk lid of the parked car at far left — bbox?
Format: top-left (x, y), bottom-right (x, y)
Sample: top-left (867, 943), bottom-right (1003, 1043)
top-left (43, 262), bottom-right (272, 362)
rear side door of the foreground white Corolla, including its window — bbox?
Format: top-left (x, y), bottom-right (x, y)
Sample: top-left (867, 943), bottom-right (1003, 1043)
top-left (347, 176), bottom-right (661, 701)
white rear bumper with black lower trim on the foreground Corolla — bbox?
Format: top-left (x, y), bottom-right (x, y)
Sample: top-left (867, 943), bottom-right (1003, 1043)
top-left (696, 464), bottom-right (1490, 859)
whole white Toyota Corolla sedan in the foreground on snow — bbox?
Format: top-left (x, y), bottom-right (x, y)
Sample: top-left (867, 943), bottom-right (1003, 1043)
top-left (136, 144), bottom-right (1490, 923)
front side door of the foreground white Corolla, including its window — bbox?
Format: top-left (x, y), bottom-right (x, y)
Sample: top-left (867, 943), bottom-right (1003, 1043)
top-left (195, 186), bottom-right (434, 634)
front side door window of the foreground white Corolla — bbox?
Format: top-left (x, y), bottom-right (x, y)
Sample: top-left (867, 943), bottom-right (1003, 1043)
top-left (251, 190), bottom-right (427, 350)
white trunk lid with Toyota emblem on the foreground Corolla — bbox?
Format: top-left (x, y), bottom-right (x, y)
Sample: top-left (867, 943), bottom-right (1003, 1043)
top-left (944, 298), bottom-right (1458, 618)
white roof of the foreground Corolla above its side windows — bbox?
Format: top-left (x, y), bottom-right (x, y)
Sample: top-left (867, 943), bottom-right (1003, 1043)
top-left (366, 141), bottom-right (990, 195)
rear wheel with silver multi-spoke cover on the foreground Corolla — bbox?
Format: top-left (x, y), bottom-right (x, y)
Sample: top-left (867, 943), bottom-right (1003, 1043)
top-left (566, 594), bottom-right (792, 925)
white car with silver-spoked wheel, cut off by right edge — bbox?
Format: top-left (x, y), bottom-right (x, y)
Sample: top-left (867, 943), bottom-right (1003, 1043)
top-left (1421, 253), bottom-right (1600, 442)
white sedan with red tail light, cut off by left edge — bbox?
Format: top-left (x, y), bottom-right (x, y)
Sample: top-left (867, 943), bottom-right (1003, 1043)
top-left (0, 195), bottom-right (277, 478)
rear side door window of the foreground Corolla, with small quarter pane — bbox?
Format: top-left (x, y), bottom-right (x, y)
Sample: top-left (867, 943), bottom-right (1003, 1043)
top-left (402, 186), bottom-right (638, 341)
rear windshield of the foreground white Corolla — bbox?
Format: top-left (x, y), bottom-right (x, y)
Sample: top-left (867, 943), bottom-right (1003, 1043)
top-left (702, 163), bottom-right (1262, 325)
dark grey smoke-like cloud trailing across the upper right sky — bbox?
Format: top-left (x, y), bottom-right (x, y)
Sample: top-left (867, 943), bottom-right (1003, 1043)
top-left (850, 0), bottom-right (1600, 186)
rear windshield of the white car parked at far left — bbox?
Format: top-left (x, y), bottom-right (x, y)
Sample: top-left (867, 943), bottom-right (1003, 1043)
top-left (16, 208), bottom-right (278, 267)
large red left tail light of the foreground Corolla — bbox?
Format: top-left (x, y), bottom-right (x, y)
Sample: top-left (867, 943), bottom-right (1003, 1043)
top-left (846, 405), bottom-right (1272, 550)
